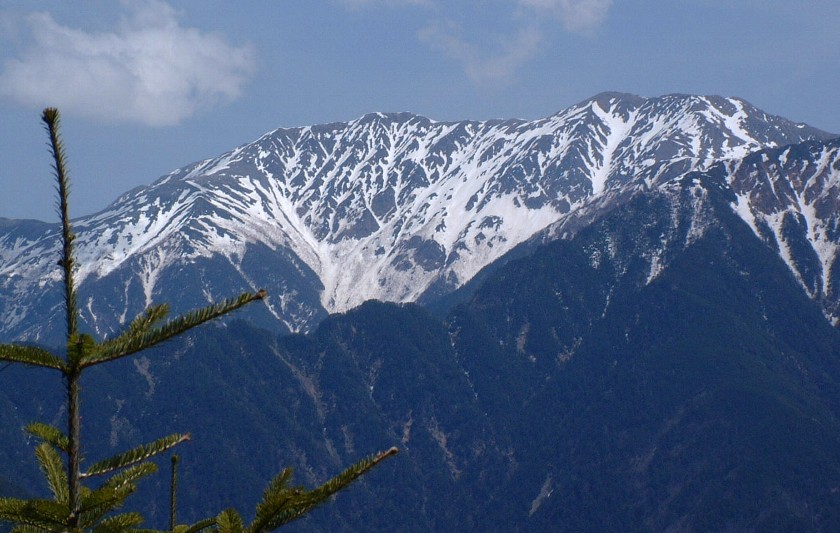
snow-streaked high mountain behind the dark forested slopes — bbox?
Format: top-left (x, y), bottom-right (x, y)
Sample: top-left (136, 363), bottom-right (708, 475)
top-left (0, 93), bottom-right (840, 339)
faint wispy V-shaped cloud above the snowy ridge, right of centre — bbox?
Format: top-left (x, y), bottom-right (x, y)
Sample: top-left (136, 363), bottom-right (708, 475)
top-left (420, 22), bottom-right (542, 82)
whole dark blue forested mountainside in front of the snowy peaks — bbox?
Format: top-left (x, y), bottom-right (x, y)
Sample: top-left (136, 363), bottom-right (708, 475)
top-left (0, 166), bottom-right (840, 531)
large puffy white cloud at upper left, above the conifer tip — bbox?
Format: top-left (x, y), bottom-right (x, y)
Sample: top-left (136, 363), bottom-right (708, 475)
top-left (0, 0), bottom-right (255, 126)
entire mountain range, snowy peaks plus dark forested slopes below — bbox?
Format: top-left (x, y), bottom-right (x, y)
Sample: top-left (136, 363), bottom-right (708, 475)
top-left (0, 93), bottom-right (840, 531)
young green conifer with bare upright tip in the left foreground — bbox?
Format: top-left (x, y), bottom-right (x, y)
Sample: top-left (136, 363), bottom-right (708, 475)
top-left (0, 108), bottom-right (397, 533)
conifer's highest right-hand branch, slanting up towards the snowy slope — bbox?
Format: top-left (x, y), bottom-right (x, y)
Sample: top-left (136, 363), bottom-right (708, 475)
top-left (81, 290), bottom-right (266, 368)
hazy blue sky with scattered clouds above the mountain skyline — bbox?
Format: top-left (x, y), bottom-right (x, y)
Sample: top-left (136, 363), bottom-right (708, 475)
top-left (0, 0), bottom-right (840, 220)
